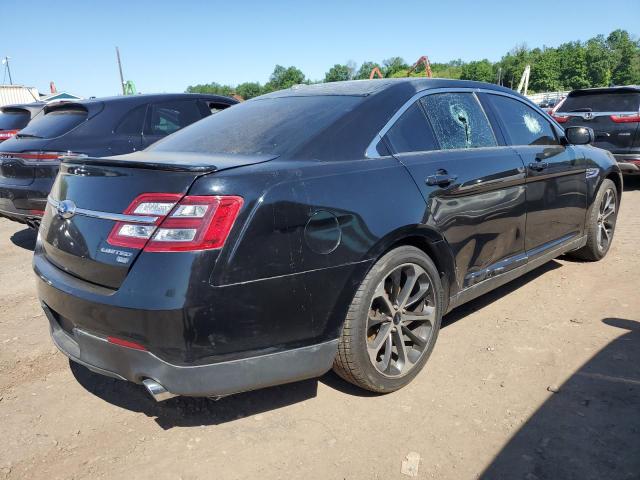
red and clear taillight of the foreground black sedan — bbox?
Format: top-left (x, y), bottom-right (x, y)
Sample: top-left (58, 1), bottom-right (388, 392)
top-left (107, 193), bottom-right (243, 252)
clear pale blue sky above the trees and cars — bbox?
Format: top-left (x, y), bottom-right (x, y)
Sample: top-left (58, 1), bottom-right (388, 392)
top-left (0, 0), bottom-right (640, 97)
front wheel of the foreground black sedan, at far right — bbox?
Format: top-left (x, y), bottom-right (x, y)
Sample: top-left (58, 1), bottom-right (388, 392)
top-left (568, 179), bottom-right (620, 262)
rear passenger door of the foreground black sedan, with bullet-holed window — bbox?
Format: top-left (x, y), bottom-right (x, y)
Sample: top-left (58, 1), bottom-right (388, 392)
top-left (384, 92), bottom-right (525, 294)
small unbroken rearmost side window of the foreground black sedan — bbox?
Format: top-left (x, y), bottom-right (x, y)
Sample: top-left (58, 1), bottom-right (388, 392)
top-left (385, 102), bottom-right (438, 153)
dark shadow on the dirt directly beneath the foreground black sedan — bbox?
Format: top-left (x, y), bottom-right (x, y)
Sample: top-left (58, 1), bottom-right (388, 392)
top-left (69, 261), bottom-right (561, 429)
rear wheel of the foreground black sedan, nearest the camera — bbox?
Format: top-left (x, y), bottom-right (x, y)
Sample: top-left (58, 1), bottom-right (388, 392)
top-left (333, 246), bottom-right (444, 393)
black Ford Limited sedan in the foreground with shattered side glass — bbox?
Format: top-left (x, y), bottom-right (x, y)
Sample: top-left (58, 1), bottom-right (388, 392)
top-left (34, 79), bottom-right (622, 399)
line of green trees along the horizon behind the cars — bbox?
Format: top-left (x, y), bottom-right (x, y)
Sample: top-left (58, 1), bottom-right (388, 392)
top-left (186, 30), bottom-right (640, 99)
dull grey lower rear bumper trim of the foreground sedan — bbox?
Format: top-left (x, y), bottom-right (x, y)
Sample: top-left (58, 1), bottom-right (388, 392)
top-left (43, 306), bottom-right (338, 397)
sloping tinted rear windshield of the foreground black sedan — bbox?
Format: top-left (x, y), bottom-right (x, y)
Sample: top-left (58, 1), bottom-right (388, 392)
top-left (149, 95), bottom-right (362, 155)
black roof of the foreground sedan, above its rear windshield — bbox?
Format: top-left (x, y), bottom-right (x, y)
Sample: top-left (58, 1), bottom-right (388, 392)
top-left (258, 77), bottom-right (515, 98)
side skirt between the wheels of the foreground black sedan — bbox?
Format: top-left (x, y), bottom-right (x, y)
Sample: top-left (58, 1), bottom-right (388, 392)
top-left (447, 236), bottom-right (587, 313)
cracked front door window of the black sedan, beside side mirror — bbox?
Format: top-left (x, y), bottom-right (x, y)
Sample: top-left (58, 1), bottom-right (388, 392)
top-left (488, 95), bottom-right (559, 145)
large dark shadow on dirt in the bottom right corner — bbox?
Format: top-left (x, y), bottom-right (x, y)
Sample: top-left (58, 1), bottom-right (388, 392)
top-left (480, 318), bottom-right (640, 480)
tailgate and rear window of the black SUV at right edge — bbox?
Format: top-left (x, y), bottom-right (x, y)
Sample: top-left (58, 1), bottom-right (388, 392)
top-left (555, 89), bottom-right (640, 154)
